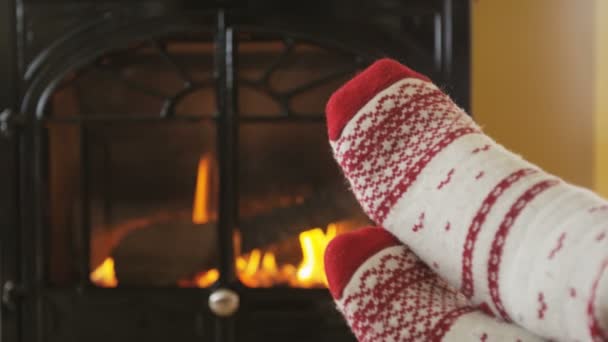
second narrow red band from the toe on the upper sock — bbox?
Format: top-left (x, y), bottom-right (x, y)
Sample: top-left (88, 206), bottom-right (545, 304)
top-left (488, 179), bottom-right (559, 322)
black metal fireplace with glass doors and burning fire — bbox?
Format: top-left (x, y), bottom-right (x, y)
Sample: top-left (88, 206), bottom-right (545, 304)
top-left (0, 0), bottom-right (468, 341)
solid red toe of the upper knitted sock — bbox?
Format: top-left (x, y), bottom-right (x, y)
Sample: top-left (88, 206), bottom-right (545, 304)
top-left (325, 58), bottom-right (430, 140)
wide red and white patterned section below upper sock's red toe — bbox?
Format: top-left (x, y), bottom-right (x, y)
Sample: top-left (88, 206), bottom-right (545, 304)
top-left (332, 78), bottom-right (480, 223)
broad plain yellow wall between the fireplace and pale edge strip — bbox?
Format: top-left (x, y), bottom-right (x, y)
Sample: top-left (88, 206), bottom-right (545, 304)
top-left (471, 0), bottom-right (596, 187)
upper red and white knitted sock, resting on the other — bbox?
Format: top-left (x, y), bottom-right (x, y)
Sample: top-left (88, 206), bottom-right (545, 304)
top-left (327, 59), bottom-right (608, 341)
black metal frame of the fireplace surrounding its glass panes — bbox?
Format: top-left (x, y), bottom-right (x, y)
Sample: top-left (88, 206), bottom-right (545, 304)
top-left (0, 0), bottom-right (466, 342)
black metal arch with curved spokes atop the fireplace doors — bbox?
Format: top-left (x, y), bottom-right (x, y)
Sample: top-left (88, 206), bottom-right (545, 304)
top-left (21, 13), bottom-right (404, 121)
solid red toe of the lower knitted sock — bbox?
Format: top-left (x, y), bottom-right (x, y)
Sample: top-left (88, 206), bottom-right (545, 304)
top-left (325, 227), bottom-right (400, 299)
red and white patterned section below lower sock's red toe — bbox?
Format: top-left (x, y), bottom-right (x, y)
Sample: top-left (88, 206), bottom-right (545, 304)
top-left (337, 246), bottom-right (470, 342)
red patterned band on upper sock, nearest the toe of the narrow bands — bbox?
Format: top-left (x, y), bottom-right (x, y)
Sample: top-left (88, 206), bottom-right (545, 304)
top-left (461, 168), bottom-right (537, 298)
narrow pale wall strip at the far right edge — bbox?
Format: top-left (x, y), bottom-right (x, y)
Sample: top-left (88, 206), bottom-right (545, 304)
top-left (594, 0), bottom-right (608, 197)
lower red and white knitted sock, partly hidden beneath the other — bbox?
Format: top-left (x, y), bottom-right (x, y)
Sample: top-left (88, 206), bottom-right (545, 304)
top-left (325, 228), bottom-right (540, 342)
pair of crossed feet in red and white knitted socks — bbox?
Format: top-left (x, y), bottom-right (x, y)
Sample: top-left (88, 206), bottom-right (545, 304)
top-left (325, 59), bottom-right (608, 342)
